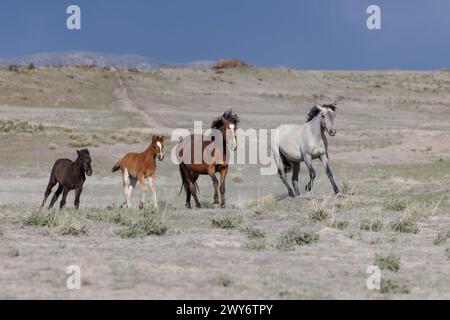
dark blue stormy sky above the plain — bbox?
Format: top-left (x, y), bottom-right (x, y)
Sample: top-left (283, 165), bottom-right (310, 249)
top-left (0, 0), bottom-right (450, 70)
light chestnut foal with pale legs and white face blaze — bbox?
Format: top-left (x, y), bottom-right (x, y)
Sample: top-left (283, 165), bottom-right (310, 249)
top-left (112, 135), bottom-right (164, 209)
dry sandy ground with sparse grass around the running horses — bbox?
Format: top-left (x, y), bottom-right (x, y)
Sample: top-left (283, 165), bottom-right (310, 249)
top-left (0, 68), bottom-right (450, 299)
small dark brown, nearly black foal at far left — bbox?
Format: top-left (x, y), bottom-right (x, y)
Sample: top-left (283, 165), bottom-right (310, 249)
top-left (41, 149), bottom-right (92, 209)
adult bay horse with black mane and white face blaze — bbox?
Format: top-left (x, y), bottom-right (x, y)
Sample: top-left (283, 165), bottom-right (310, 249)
top-left (178, 110), bottom-right (239, 208)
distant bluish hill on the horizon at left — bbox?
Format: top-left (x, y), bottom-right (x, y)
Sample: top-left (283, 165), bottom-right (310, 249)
top-left (0, 51), bottom-right (213, 69)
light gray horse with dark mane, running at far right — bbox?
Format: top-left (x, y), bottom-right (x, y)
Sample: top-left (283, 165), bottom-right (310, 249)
top-left (272, 104), bottom-right (339, 197)
